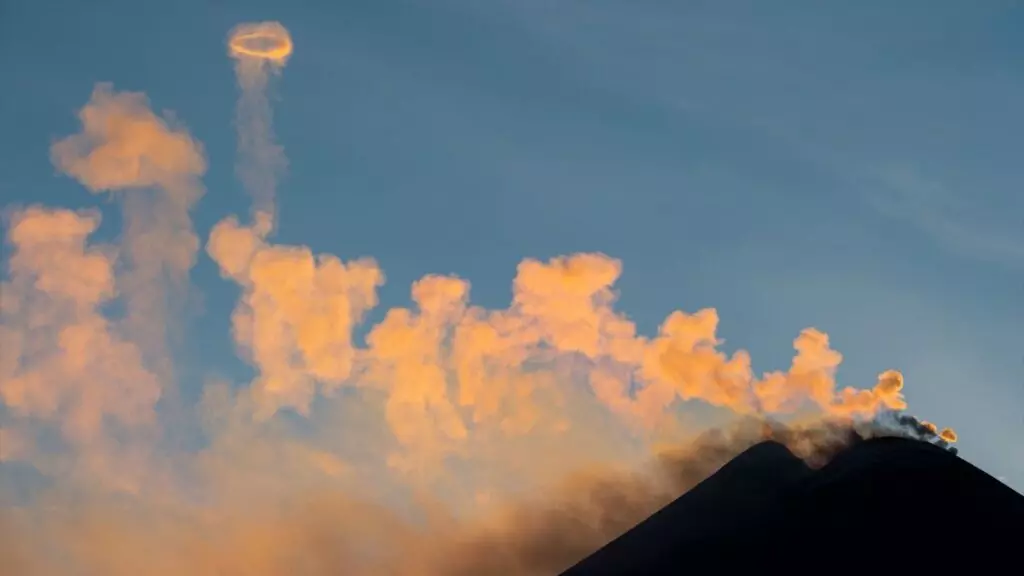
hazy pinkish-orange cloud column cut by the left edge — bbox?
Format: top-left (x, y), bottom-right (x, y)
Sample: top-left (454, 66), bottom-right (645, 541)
top-left (0, 207), bottom-right (161, 487)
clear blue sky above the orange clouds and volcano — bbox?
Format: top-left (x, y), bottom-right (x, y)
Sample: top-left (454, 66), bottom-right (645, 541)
top-left (0, 0), bottom-right (1024, 489)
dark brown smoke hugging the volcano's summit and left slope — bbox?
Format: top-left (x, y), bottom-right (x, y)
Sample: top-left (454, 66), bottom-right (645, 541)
top-left (419, 414), bottom-right (954, 576)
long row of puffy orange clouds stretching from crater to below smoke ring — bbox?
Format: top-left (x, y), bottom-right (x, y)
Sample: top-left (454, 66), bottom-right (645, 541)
top-left (201, 237), bottom-right (929, 472)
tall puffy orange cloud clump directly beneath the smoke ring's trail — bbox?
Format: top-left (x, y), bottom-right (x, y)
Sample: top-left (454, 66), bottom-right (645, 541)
top-left (208, 218), bottom-right (384, 416)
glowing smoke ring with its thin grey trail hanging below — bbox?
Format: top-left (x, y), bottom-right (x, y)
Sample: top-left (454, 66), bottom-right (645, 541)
top-left (227, 22), bottom-right (293, 235)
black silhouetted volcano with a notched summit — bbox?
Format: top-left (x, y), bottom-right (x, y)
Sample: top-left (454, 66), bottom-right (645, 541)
top-left (562, 438), bottom-right (1024, 576)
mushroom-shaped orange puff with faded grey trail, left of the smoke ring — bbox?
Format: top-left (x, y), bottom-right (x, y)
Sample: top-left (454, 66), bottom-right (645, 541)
top-left (50, 83), bottom-right (206, 399)
